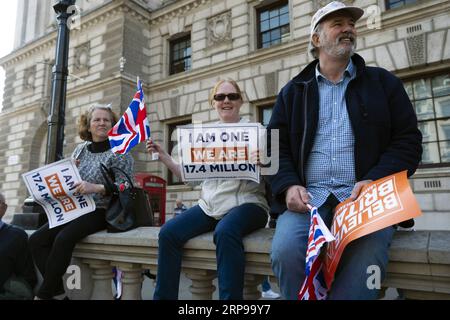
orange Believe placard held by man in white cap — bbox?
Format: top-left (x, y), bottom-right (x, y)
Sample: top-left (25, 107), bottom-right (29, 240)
top-left (324, 171), bottom-right (422, 288)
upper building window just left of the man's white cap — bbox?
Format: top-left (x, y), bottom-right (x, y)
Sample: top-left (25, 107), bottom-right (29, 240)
top-left (257, 1), bottom-right (289, 48)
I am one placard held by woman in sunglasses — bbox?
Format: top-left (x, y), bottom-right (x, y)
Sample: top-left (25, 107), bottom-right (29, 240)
top-left (177, 123), bottom-right (261, 183)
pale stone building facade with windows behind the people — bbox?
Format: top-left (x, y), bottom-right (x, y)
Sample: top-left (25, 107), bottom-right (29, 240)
top-left (0, 0), bottom-right (450, 230)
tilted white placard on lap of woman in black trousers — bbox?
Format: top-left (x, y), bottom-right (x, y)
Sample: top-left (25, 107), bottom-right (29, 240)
top-left (22, 159), bottom-right (95, 228)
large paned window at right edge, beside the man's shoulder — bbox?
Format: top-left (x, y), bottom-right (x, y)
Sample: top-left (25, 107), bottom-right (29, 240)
top-left (405, 74), bottom-right (450, 166)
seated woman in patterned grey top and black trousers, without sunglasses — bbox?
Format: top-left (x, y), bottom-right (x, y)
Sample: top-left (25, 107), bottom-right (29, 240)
top-left (29, 105), bottom-right (134, 299)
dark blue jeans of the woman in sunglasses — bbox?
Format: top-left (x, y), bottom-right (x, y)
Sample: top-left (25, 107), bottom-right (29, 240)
top-left (153, 203), bottom-right (268, 300)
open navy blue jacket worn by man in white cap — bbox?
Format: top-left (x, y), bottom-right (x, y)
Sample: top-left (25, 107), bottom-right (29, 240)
top-left (268, 54), bottom-right (422, 213)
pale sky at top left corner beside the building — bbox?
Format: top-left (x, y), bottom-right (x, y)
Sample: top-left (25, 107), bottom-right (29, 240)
top-left (0, 0), bottom-right (18, 110)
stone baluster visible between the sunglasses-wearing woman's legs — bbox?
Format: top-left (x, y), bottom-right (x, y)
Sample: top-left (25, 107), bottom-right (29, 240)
top-left (184, 269), bottom-right (216, 300)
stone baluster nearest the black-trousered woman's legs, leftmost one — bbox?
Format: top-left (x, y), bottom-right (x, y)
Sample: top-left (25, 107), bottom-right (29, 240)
top-left (83, 259), bottom-right (113, 300)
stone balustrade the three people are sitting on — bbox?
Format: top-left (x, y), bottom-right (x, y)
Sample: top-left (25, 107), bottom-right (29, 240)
top-left (69, 227), bottom-right (450, 300)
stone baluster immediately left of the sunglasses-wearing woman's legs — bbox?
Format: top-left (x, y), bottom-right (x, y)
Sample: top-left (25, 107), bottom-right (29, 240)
top-left (113, 262), bottom-right (143, 300)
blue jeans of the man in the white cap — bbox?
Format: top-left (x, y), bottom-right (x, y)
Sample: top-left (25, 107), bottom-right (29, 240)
top-left (271, 196), bottom-right (395, 300)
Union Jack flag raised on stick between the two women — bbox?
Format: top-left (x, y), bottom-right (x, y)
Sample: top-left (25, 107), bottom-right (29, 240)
top-left (108, 78), bottom-right (150, 154)
